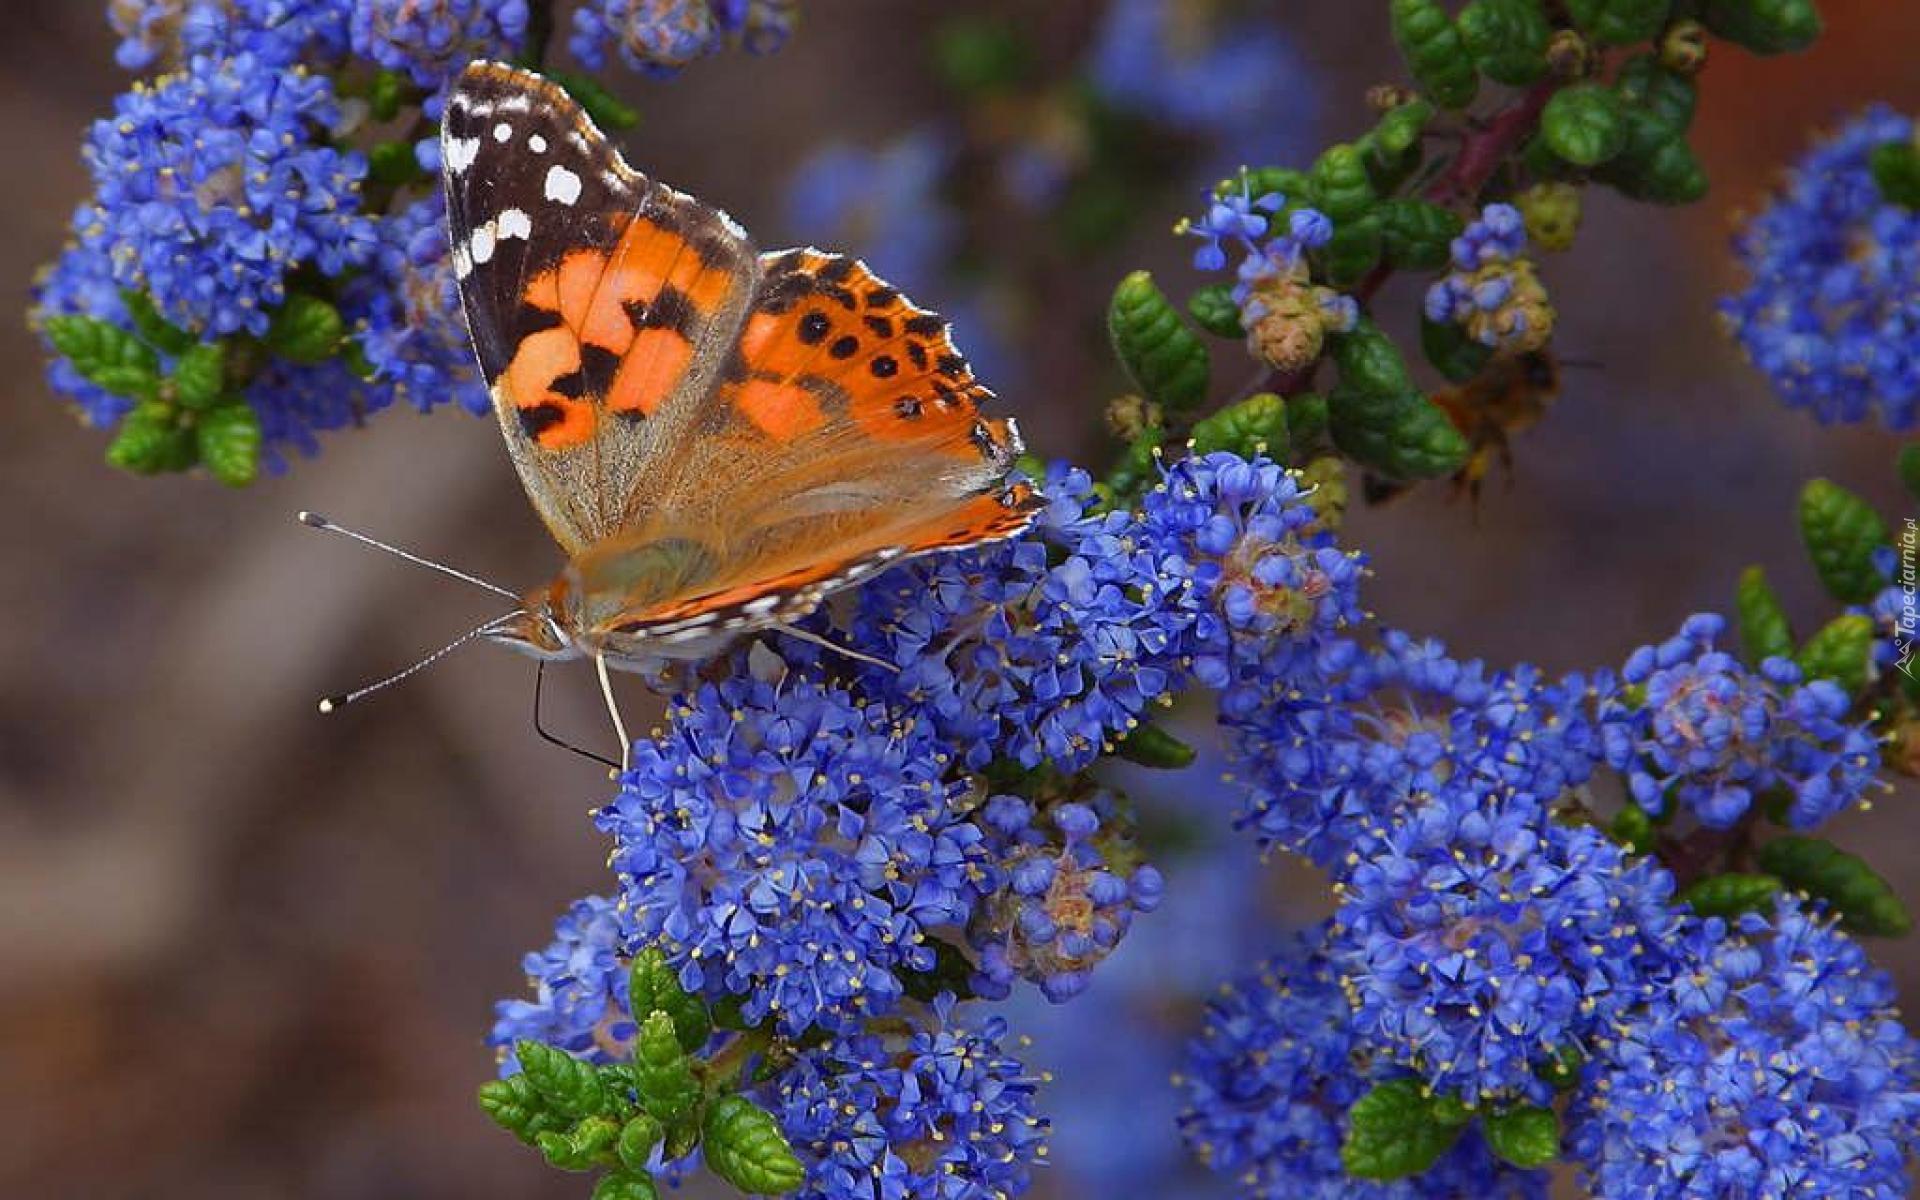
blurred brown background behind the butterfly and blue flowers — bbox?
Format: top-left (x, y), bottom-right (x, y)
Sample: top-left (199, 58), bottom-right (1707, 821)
top-left (0, 0), bottom-right (1920, 1200)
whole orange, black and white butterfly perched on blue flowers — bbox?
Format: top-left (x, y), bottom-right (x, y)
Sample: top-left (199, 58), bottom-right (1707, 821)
top-left (440, 61), bottom-right (1044, 710)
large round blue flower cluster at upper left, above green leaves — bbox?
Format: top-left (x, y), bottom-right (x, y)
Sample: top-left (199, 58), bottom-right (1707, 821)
top-left (75, 54), bottom-right (374, 336)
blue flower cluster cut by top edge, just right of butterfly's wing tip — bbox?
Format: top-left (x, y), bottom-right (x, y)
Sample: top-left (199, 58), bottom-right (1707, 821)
top-left (566, 0), bottom-right (801, 75)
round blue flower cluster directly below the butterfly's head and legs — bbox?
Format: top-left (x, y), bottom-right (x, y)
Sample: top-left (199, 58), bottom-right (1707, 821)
top-left (599, 674), bottom-right (995, 1033)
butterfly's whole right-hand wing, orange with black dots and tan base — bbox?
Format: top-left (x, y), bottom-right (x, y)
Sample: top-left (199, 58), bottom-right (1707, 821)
top-left (576, 250), bottom-right (1043, 639)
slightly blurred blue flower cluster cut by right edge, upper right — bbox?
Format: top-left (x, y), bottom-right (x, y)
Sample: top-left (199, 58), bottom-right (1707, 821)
top-left (1720, 106), bottom-right (1920, 430)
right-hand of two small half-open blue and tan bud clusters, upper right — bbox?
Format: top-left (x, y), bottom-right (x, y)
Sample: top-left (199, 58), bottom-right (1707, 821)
top-left (1427, 204), bottom-right (1553, 353)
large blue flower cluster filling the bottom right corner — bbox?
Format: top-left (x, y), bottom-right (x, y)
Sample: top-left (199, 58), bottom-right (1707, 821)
top-left (1567, 899), bottom-right (1920, 1200)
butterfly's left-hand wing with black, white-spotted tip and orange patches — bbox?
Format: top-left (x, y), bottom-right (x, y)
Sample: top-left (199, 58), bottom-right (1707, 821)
top-left (440, 63), bottom-right (760, 555)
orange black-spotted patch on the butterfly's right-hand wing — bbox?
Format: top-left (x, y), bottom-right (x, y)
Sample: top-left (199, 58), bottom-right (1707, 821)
top-left (728, 250), bottom-right (1016, 465)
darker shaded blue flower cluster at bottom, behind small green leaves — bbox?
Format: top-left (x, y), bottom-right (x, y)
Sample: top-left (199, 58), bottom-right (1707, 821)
top-left (1177, 925), bottom-right (1548, 1200)
